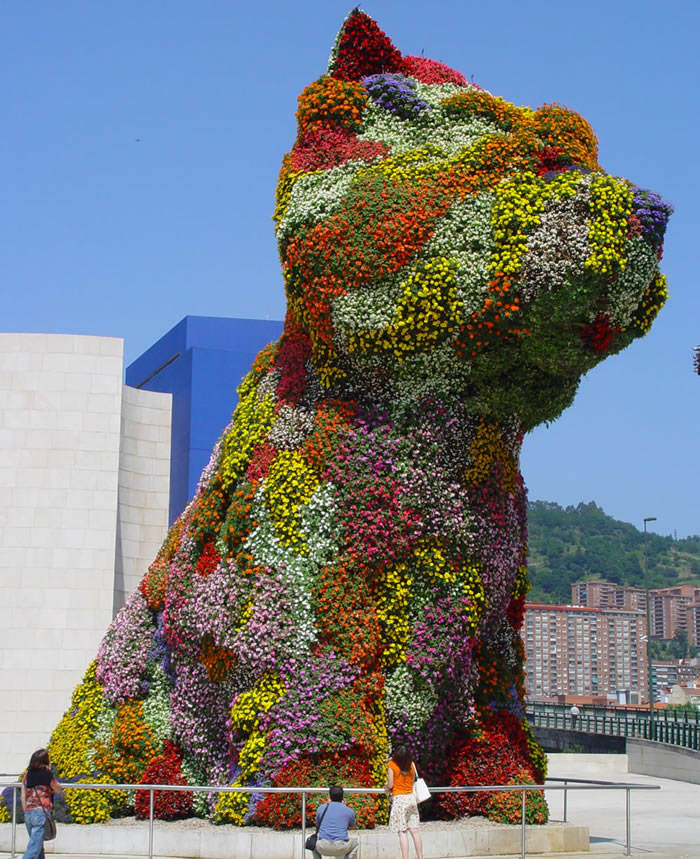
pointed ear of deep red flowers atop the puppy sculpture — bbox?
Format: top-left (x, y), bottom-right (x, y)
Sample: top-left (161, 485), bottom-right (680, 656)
top-left (328, 7), bottom-right (403, 81)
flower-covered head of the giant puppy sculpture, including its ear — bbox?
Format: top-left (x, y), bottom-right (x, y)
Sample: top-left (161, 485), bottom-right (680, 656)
top-left (275, 10), bottom-right (671, 429)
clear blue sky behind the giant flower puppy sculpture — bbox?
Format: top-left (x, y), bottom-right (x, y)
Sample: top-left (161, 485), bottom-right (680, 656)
top-left (5, 0), bottom-right (700, 536)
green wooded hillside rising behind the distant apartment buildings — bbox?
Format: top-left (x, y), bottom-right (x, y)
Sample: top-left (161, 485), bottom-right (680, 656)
top-left (528, 501), bottom-right (700, 603)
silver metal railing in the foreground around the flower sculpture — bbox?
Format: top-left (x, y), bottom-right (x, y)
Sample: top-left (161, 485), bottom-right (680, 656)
top-left (0, 778), bottom-right (660, 859)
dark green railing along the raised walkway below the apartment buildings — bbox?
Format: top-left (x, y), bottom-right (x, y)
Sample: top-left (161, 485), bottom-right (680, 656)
top-left (525, 704), bottom-right (700, 751)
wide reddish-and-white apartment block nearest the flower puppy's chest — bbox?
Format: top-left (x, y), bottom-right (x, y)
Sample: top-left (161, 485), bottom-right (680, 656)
top-left (521, 603), bottom-right (648, 700)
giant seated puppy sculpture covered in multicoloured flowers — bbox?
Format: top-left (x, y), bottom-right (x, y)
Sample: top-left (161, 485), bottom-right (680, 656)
top-left (43, 10), bottom-right (670, 826)
